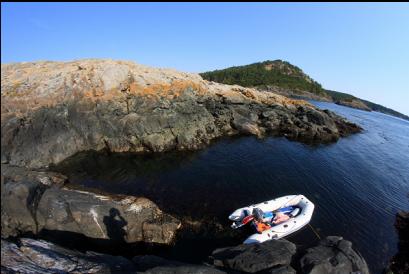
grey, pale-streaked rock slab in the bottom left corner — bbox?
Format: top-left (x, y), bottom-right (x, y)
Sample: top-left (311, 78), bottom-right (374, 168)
top-left (1, 238), bottom-right (136, 273)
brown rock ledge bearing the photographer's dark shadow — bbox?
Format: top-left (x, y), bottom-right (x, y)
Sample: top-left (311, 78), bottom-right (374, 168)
top-left (1, 165), bottom-right (181, 244)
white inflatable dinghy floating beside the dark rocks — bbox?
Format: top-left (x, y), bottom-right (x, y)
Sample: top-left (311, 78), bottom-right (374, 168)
top-left (229, 195), bottom-right (314, 244)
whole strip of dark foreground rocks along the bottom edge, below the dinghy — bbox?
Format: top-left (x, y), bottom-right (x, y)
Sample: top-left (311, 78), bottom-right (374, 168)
top-left (1, 236), bottom-right (369, 274)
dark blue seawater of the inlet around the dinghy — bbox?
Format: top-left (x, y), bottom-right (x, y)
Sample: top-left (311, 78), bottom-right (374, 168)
top-left (56, 102), bottom-right (409, 273)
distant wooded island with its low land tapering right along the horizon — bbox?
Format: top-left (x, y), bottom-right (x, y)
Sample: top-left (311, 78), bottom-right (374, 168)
top-left (200, 60), bottom-right (409, 120)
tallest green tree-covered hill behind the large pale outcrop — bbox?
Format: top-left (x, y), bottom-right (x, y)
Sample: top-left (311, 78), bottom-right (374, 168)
top-left (200, 60), bottom-right (325, 95)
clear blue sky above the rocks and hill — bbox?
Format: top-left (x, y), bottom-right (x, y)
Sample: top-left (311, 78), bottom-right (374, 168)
top-left (1, 3), bottom-right (409, 115)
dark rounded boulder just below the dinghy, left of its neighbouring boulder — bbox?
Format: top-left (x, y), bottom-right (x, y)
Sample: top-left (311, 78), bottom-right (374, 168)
top-left (211, 240), bottom-right (296, 273)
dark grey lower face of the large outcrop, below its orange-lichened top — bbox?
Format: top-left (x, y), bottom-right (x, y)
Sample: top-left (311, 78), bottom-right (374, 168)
top-left (2, 89), bottom-right (359, 168)
